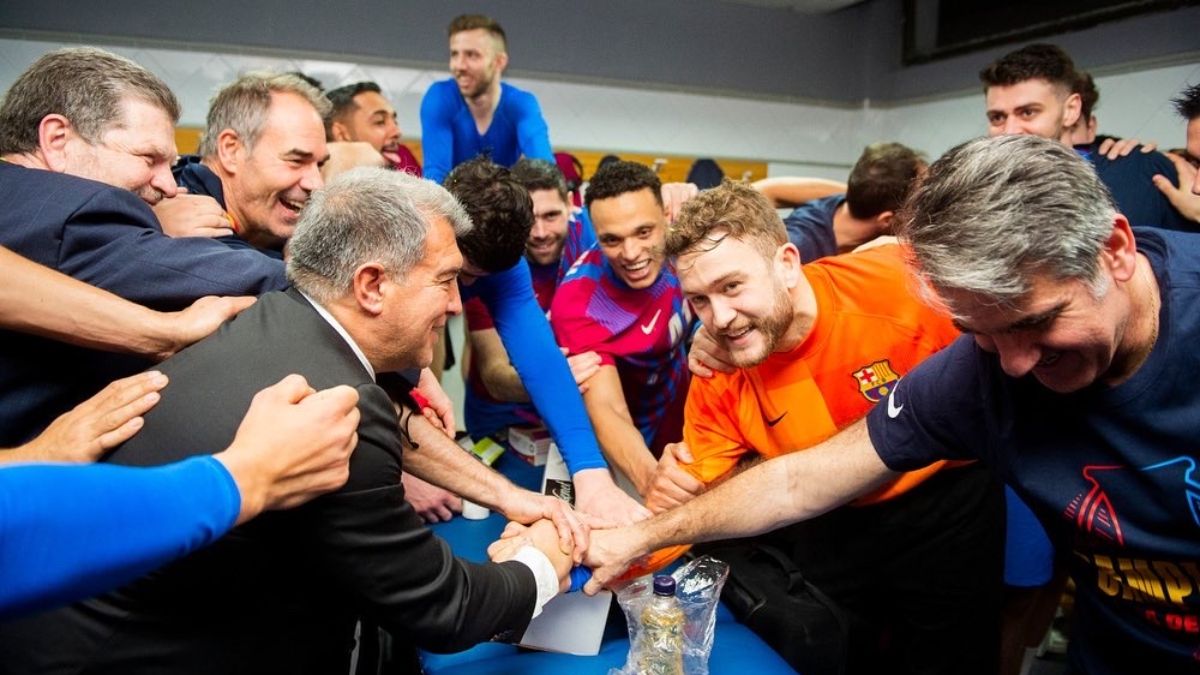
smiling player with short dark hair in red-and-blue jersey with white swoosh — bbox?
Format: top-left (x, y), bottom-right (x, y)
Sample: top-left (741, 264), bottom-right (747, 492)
top-left (550, 162), bottom-right (692, 495)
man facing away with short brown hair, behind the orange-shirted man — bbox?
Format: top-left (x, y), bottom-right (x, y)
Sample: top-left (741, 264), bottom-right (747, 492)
top-left (755, 143), bottom-right (925, 263)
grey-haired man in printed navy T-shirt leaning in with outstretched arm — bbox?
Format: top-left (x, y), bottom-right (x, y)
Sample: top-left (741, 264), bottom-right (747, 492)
top-left (589, 136), bottom-right (1200, 674)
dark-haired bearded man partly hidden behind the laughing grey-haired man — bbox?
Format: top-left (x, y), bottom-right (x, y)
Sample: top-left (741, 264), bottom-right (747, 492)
top-left (325, 82), bottom-right (421, 177)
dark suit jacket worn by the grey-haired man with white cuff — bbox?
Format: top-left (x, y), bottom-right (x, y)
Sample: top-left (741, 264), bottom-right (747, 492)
top-left (0, 285), bottom-right (536, 675)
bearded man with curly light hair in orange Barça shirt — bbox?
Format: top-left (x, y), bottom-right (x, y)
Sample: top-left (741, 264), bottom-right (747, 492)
top-left (633, 183), bottom-right (1003, 673)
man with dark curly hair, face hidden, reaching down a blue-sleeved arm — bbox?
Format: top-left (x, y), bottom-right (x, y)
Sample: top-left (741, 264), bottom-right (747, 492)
top-left (446, 159), bottom-right (649, 522)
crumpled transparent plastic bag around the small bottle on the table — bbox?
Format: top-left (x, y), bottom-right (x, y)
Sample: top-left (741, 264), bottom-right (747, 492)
top-left (608, 556), bottom-right (730, 675)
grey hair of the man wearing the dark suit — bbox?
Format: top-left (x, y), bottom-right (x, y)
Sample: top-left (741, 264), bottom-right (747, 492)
top-left (288, 167), bottom-right (472, 303)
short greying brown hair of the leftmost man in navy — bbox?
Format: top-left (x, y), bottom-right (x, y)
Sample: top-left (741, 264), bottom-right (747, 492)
top-left (0, 47), bottom-right (179, 154)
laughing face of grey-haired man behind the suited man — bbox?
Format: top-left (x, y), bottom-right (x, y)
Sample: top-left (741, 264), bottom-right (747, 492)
top-left (224, 92), bottom-right (329, 247)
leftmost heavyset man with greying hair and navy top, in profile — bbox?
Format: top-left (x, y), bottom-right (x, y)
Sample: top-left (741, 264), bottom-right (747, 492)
top-left (0, 48), bottom-right (284, 447)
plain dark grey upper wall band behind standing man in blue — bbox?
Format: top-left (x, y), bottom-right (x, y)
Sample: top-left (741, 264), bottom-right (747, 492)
top-left (0, 0), bottom-right (864, 101)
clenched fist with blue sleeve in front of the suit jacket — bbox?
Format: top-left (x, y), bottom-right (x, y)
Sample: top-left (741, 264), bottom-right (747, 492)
top-left (215, 375), bottom-right (359, 522)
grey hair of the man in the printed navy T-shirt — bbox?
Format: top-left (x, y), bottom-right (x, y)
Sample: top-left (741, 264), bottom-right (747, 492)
top-left (898, 136), bottom-right (1117, 305)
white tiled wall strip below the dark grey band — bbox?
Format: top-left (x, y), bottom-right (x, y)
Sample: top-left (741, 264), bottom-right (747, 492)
top-left (0, 40), bottom-right (1200, 172)
